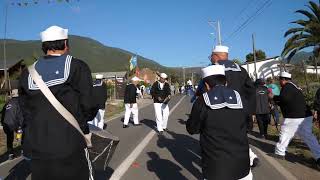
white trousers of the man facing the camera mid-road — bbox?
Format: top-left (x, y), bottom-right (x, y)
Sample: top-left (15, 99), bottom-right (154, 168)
top-left (154, 103), bottom-right (169, 131)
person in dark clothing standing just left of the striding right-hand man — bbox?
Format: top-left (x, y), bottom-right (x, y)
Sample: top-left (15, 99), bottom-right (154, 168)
top-left (256, 79), bottom-right (270, 139)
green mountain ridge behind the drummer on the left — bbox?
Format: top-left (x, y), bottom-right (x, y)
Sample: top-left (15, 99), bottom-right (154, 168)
top-left (0, 35), bottom-right (173, 72)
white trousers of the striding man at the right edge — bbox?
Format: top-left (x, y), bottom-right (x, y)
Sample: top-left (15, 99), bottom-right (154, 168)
top-left (275, 116), bottom-right (320, 159)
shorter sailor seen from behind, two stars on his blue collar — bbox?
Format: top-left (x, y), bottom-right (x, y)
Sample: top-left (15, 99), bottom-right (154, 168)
top-left (186, 65), bottom-right (252, 180)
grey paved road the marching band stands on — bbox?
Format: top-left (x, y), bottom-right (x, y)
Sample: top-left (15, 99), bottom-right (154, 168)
top-left (0, 95), bottom-right (285, 180)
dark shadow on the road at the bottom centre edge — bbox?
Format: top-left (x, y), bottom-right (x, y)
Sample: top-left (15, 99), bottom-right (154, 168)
top-left (147, 152), bottom-right (188, 180)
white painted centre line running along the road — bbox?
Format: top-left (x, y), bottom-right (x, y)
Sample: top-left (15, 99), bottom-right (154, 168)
top-left (109, 96), bottom-right (186, 180)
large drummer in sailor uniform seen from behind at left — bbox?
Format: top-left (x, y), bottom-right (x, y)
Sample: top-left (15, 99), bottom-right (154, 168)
top-left (19, 26), bottom-right (97, 180)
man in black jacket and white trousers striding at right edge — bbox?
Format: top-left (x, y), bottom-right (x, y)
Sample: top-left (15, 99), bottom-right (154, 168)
top-left (274, 72), bottom-right (320, 166)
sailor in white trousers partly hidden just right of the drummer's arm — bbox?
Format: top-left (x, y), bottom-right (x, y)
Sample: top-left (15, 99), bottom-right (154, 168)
top-left (89, 74), bottom-right (107, 129)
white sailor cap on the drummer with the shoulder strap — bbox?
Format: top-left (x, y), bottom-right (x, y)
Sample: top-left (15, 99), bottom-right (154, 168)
top-left (40, 26), bottom-right (68, 42)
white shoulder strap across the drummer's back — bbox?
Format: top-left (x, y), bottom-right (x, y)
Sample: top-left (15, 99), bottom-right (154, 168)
top-left (28, 64), bottom-right (91, 145)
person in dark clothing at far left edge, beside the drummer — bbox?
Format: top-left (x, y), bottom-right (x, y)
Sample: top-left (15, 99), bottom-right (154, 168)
top-left (1, 89), bottom-right (23, 160)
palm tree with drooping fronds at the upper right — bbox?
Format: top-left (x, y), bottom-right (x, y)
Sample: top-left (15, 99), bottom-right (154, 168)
top-left (281, 1), bottom-right (320, 62)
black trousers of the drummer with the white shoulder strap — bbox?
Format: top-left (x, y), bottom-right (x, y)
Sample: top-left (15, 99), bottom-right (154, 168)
top-left (31, 150), bottom-right (91, 180)
